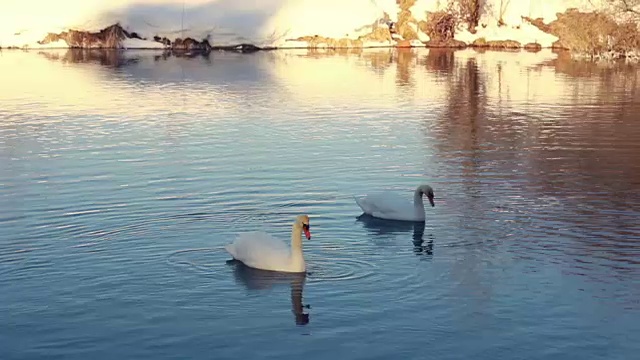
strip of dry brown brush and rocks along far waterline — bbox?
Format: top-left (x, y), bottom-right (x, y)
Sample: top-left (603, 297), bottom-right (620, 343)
top-left (0, 8), bottom-right (640, 62)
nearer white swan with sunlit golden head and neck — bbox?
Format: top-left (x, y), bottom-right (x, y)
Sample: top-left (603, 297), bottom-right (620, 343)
top-left (224, 215), bottom-right (311, 273)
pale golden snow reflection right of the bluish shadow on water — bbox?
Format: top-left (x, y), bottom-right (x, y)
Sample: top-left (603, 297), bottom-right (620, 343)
top-left (270, 49), bottom-right (632, 109)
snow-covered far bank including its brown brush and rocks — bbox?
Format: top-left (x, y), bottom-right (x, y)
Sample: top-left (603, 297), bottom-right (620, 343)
top-left (0, 0), bottom-right (640, 59)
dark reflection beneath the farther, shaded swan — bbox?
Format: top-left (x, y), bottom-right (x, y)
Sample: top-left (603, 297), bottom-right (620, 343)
top-left (357, 214), bottom-right (433, 256)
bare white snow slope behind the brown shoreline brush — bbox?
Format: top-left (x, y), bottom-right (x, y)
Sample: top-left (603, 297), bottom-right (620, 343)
top-left (0, 0), bottom-right (605, 48)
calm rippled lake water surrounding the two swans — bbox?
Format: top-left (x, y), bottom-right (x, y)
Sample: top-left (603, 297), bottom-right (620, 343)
top-left (0, 49), bottom-right (640, 360)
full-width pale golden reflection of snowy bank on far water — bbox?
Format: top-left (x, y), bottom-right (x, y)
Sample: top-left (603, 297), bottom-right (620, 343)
top-left (5, 49), bottom-right (640, 117)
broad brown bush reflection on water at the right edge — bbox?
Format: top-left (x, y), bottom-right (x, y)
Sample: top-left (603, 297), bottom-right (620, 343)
top-left (528, 59), bottom-right (640, 200)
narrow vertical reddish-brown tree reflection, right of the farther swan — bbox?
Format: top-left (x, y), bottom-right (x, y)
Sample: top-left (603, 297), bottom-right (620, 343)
top-left (426, 52), bottom-right (493, 306)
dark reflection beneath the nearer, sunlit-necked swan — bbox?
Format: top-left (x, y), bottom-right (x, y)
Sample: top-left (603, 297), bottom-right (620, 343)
top-left (227, 260), bottom-right (311, 325)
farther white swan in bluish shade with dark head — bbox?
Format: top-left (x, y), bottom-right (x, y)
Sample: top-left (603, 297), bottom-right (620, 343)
top-left (354, 185), bottom-right (435, 221)
